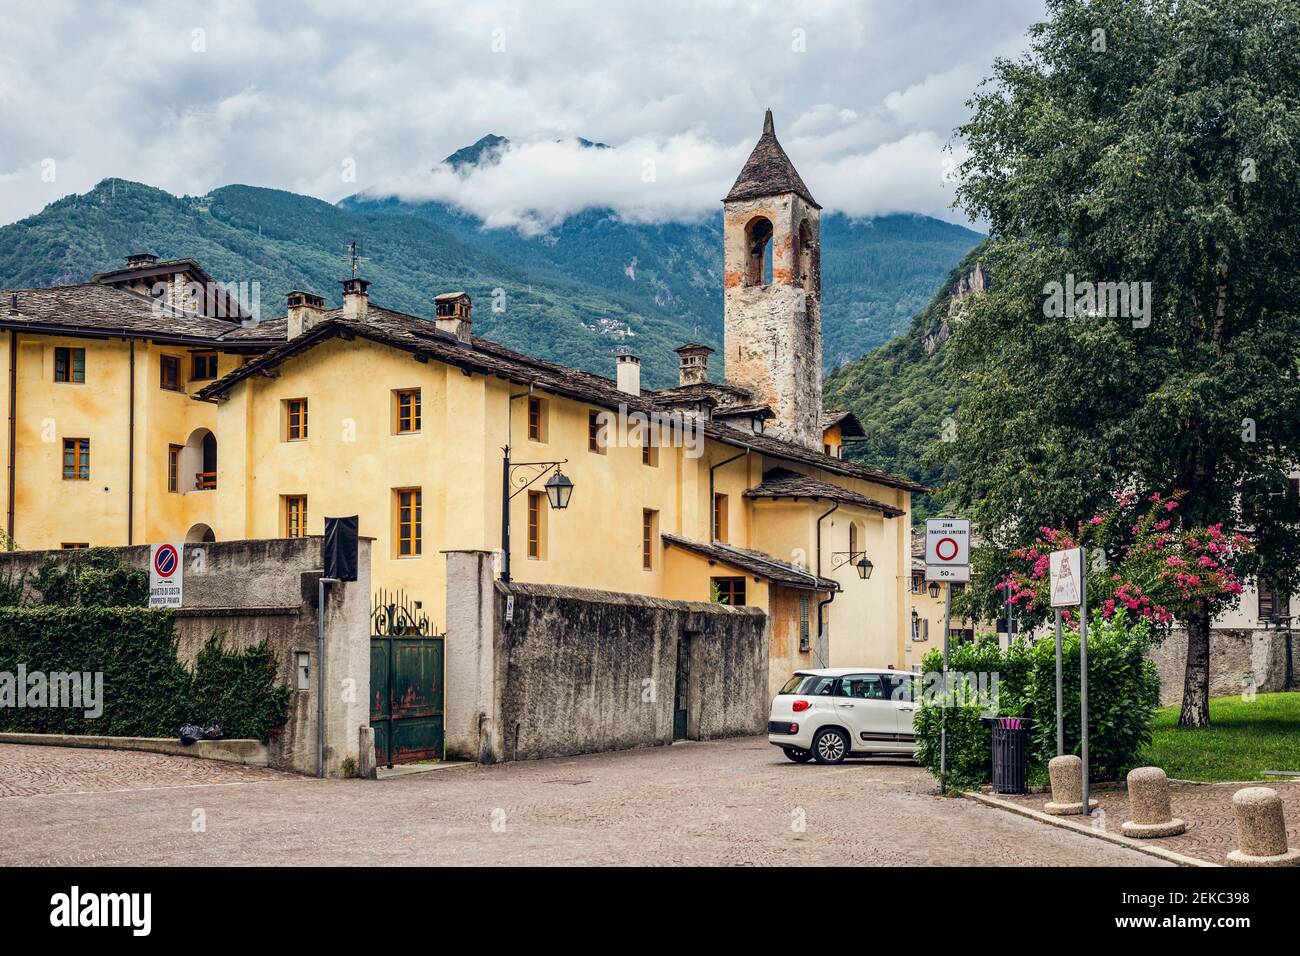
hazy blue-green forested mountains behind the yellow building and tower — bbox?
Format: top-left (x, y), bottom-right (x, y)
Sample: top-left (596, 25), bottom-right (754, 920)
top-left (0, 135), bottom-right (982, 388)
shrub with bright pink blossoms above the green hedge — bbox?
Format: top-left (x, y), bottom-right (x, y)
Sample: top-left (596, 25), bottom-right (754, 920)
top-left (997, 492), bottom-right (1249, 627)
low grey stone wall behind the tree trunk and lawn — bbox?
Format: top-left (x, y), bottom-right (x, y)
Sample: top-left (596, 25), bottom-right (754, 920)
top-left (1148, 628), bottom-right (1300, 706)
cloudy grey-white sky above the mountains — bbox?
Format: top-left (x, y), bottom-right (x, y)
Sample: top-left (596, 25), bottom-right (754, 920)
top-left (0, 0), bottom-right (1043, 229)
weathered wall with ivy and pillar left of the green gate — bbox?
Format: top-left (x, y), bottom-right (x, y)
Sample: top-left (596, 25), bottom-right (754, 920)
top-left (0, 536), bottom-right (371, 775)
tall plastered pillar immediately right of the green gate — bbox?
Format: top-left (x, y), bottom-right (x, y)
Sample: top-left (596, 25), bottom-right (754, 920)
top-left (443, 550), bottom-right (504, 763)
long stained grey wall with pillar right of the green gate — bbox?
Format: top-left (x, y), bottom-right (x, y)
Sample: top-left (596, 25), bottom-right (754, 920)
top-left (446, 551), bottom-right (768, 763)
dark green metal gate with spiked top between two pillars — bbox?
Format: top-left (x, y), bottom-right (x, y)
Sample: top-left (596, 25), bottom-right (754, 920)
top-left (371, 591), bottom-right (445, 766)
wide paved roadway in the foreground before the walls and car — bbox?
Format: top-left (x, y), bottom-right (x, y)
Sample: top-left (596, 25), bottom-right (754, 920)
top-left (0, 737), bottom-right (1160, 866)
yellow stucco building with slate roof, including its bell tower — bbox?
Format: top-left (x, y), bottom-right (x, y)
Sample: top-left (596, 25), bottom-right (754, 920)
top-left (0, 117), bottom-right (919, 687)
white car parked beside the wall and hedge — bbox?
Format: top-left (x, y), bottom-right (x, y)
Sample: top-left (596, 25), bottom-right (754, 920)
top-left (767, 667), bottom-right (919, 763)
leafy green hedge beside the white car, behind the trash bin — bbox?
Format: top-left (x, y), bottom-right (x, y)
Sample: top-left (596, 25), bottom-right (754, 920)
top-left (915, 615), bottom-right (1160, 790)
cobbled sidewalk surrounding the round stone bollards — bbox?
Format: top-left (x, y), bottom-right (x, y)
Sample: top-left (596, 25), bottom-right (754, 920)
top-left (997, 780), bottom-right (1300, 864)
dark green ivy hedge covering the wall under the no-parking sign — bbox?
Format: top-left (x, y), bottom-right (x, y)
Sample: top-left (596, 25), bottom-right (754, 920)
top-left (0, 606), bottom-right (289, 741)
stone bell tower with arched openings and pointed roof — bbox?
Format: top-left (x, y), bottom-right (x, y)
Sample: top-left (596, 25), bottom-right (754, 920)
top-left (723, 109), bottom-right (822, 450)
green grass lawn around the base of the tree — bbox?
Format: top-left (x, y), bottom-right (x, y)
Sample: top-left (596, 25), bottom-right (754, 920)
top-left (1141, 693), bottom-right (1300, 780)
